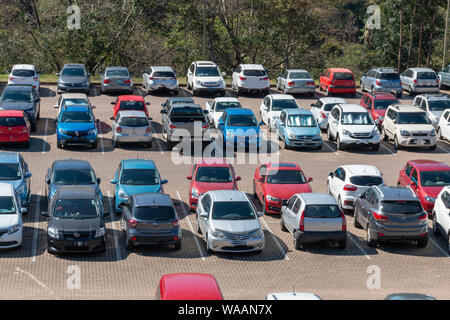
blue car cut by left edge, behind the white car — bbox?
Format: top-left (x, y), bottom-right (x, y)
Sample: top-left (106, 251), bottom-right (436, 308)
top-left (0, 152), bottom-right (31, 208)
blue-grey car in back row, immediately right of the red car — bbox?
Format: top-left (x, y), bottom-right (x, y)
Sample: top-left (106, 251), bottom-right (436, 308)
top-left (360, 68), bottom-right (403, 98)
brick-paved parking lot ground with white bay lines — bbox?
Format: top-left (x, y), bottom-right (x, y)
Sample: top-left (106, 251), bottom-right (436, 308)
top-left (0, 85), bottom-right (450, 299)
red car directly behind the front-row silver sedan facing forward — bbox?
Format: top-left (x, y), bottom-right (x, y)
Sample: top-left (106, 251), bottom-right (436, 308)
top-left (186, 158), bottom-right (241, 211)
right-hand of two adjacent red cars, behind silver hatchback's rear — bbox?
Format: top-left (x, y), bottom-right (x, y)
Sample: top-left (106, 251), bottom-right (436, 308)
top-left (253, 162), bottom-right (312, 214)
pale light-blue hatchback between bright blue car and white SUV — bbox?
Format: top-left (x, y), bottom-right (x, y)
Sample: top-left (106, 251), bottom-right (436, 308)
top-left (277, 109), bottom-right (322, 149)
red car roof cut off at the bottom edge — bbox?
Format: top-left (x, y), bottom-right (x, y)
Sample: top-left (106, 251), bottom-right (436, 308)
top-left (155, 273), bottom-right (223, 300)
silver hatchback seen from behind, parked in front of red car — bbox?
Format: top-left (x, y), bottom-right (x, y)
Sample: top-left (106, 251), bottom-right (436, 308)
top-left (111, 111), bottom-right (152, 148)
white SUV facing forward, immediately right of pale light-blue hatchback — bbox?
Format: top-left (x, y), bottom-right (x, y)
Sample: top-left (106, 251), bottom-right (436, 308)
top-left (327, 104), bottom-right (380, 151)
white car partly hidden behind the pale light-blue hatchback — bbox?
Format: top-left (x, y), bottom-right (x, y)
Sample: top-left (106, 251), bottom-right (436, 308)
top-left (259, 94), bottom-right (300, 131)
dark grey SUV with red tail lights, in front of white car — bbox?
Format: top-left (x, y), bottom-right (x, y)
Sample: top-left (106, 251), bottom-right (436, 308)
top-left (353, 186), bottom-right (428, 248)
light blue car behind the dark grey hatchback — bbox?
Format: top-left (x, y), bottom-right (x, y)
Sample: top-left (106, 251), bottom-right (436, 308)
top-left (111, 159), bottom-right (167, 212)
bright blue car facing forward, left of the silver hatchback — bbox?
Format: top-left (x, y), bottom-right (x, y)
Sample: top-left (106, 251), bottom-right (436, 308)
top-left (56, 105), bottom-right (98, 149)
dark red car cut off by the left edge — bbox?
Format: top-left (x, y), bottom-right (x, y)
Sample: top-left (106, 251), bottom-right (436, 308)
top-left (0, 110), bottom-right (30, 148)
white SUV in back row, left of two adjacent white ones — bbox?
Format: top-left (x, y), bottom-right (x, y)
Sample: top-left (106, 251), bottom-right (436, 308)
top-left (187, 61), bottom-right (226, 96)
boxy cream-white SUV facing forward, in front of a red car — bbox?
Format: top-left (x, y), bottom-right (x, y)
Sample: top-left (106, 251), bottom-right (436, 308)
top-left (381, 105), bottom-right (438, 150)
